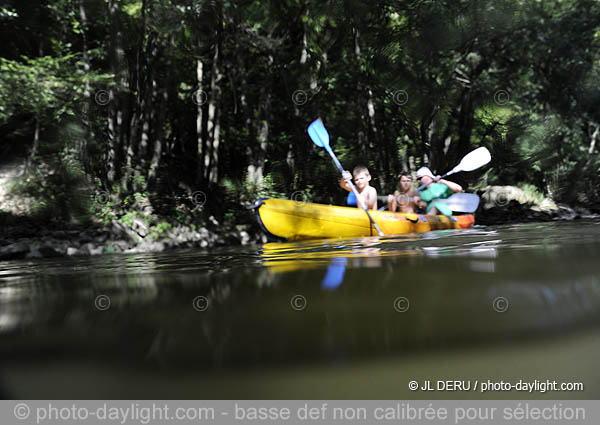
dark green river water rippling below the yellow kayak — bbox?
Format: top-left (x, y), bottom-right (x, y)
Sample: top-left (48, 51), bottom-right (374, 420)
top-left (0, 220), bottom-right (600, 399)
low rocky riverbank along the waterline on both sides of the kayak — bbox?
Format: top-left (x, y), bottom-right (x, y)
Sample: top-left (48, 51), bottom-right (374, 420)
top-left (0, 181), bottom-right (599, 260)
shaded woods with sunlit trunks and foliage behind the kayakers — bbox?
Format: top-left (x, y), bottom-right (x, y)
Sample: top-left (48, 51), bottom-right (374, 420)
top-left (0, 0), bottom-right (600, 232)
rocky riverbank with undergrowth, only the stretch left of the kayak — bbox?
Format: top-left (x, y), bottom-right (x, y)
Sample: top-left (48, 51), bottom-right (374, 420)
top-left (0, 160), bottom-right (266, 261)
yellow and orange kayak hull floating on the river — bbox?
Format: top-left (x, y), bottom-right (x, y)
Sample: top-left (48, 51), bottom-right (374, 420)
top-left (255, 199), bottom-right (475, 241)
